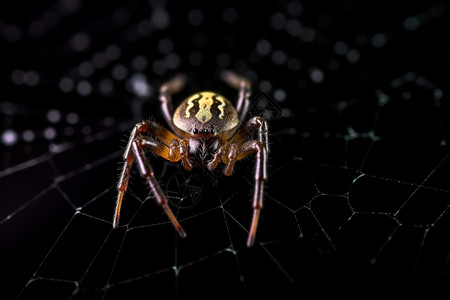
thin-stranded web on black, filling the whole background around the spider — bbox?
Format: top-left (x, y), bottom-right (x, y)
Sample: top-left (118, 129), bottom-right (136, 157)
top-left (0, 0), bottom-right (450, 299)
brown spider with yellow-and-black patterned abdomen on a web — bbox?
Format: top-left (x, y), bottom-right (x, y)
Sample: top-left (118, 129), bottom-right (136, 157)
top-left (113, 71), bottom-right (269, 247)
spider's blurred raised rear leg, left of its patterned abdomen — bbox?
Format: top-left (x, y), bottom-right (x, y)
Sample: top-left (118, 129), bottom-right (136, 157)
top-left (159, 74), bottom-right (186, 137)
